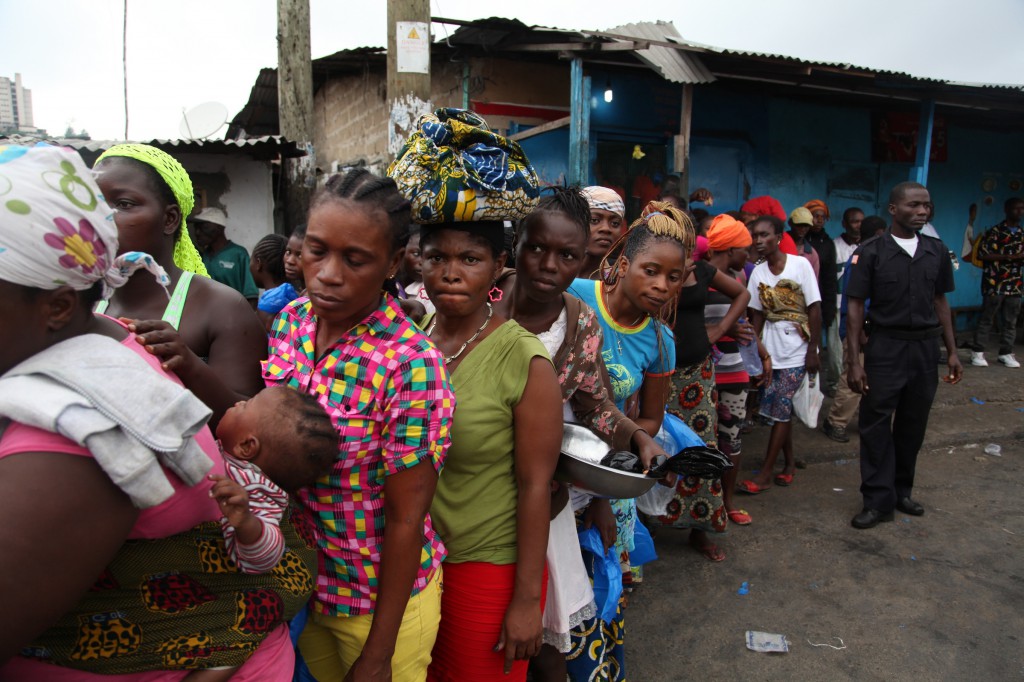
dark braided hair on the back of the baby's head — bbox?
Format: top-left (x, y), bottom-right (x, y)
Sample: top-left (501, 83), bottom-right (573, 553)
top-left (265, 386), bottom-right (338, 492)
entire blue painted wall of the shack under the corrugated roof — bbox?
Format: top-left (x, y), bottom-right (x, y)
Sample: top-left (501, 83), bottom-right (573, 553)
top-left (522, 76), bottom-right (1024, 326)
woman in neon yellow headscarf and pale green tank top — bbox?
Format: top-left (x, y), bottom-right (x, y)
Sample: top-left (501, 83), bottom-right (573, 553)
top-left (94, 144), bottom-right (266, 415)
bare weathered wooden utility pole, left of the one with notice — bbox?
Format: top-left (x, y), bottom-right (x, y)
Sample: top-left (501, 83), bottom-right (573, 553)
top-left (278, 0), bottom-right (316, 235)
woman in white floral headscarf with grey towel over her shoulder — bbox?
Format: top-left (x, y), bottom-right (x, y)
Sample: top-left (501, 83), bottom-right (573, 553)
top-left (0, 146), bottom-right (316, 682)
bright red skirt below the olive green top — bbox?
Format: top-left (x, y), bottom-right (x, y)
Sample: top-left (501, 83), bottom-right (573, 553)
top-left (427, 562), bottom-right (548, 682)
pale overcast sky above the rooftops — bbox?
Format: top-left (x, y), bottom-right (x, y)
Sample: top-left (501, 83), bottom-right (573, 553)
top-left (0, 0), bottom-right (1024, 139)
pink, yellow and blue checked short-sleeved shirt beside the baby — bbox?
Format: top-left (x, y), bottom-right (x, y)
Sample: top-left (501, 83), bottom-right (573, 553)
top-left (263, 295), bottom-right (455, 615)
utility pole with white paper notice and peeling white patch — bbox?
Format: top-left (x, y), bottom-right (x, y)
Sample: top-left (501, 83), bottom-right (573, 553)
top-left (387, 0), bottom-right (433, 157)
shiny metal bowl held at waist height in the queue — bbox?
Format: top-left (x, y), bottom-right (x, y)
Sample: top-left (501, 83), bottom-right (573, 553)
top-left (555, 424), bottom-right (657, 500)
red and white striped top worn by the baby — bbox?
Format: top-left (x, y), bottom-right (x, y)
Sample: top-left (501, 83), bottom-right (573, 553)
top-left (220, 451), bottom-right (288, 573)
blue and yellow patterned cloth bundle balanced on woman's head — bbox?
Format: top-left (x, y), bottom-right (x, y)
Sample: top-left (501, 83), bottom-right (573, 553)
top-left (387, 109), bottom-right (541, 224)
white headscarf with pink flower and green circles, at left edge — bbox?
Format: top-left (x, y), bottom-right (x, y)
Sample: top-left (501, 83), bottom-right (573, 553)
top-left (0, 144), bottom-right (169, 298)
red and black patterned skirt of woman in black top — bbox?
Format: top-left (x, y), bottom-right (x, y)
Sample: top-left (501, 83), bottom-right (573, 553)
top-left (658, 355), bottom-right (728, 532)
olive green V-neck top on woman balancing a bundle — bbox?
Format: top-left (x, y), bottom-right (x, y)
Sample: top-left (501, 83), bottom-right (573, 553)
top-left (430, 321), bottom-right (548, 565)
